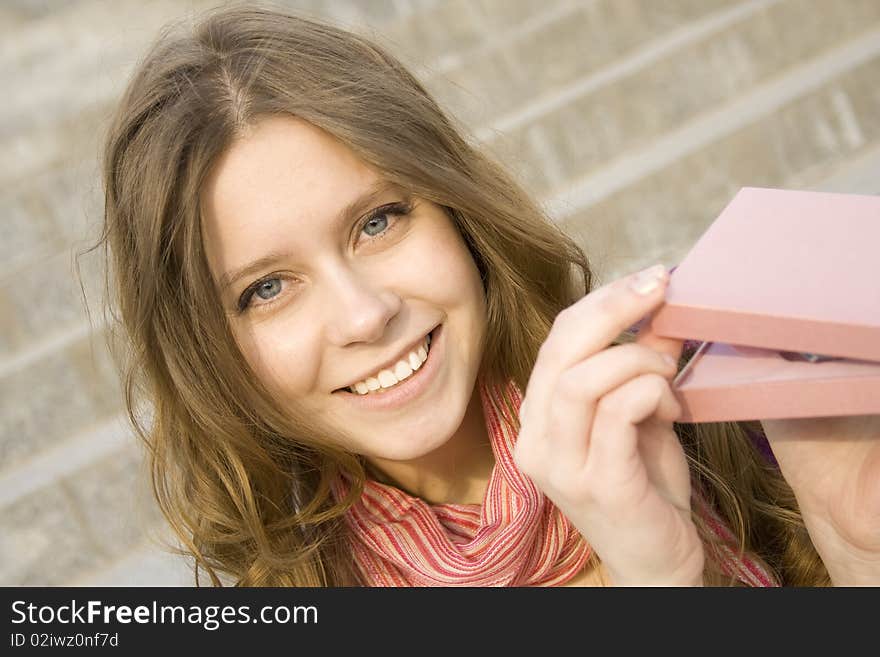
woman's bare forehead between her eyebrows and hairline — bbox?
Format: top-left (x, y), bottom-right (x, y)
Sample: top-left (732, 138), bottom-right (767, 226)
top-left (200, 116), bottom-right (380, 270)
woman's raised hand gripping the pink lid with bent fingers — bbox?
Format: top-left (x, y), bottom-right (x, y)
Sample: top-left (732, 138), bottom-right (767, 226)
top-left (514, 267), bottom-right (704, 586)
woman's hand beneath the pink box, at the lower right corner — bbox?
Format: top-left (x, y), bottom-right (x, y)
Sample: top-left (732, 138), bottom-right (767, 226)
top-left (761, 415), bottom-right (880, 586)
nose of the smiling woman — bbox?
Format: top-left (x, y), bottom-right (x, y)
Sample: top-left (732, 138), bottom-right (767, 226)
top-left (325, 267), bottom-right (401, 347)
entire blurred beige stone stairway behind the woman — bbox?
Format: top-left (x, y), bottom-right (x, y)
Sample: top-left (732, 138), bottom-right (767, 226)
top-left (0, 0), bottom-right (880, 586)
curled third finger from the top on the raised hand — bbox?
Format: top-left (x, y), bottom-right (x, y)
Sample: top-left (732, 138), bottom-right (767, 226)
top-left (589, 373), bottom-right (682, 480)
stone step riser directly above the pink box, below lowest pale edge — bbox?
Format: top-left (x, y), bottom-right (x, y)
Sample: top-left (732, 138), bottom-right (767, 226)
top-left (560, 47), bottom-right (880, 280)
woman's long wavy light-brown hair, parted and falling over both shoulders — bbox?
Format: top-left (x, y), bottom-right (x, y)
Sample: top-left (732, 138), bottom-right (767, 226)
top-left (84, 0), bottom-right (827, 586)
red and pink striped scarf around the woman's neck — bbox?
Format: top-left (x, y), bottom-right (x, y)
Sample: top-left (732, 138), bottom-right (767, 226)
top-left (332, 374), bottom-right (773, 586)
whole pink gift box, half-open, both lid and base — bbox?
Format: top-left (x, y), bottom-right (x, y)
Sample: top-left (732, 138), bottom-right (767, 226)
top-left (650, 187), bottom-right (880, 422)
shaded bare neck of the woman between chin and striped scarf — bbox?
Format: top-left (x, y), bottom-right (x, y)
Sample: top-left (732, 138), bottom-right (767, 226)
top-left (367, 386), bottom-right (495, 504)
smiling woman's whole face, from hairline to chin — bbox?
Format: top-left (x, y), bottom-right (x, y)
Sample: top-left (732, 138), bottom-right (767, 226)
top-left (201, 117), bottom-right (486, 461)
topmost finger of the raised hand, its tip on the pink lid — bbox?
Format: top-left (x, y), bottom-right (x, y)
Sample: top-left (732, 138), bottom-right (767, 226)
top-left (525, 265), bottom-right (674, 420)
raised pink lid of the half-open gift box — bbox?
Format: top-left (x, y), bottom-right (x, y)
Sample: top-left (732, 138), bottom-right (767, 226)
top-left (651, 187), bottom-right (880, 361)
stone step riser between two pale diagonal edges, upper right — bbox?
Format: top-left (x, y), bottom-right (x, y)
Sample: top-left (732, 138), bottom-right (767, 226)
top-left (484, 0), bottom-right (880, 196)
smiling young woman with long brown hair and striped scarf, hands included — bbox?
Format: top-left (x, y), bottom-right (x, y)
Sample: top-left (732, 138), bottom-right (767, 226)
top-left (86, 2), bottom-right (880, 586)
